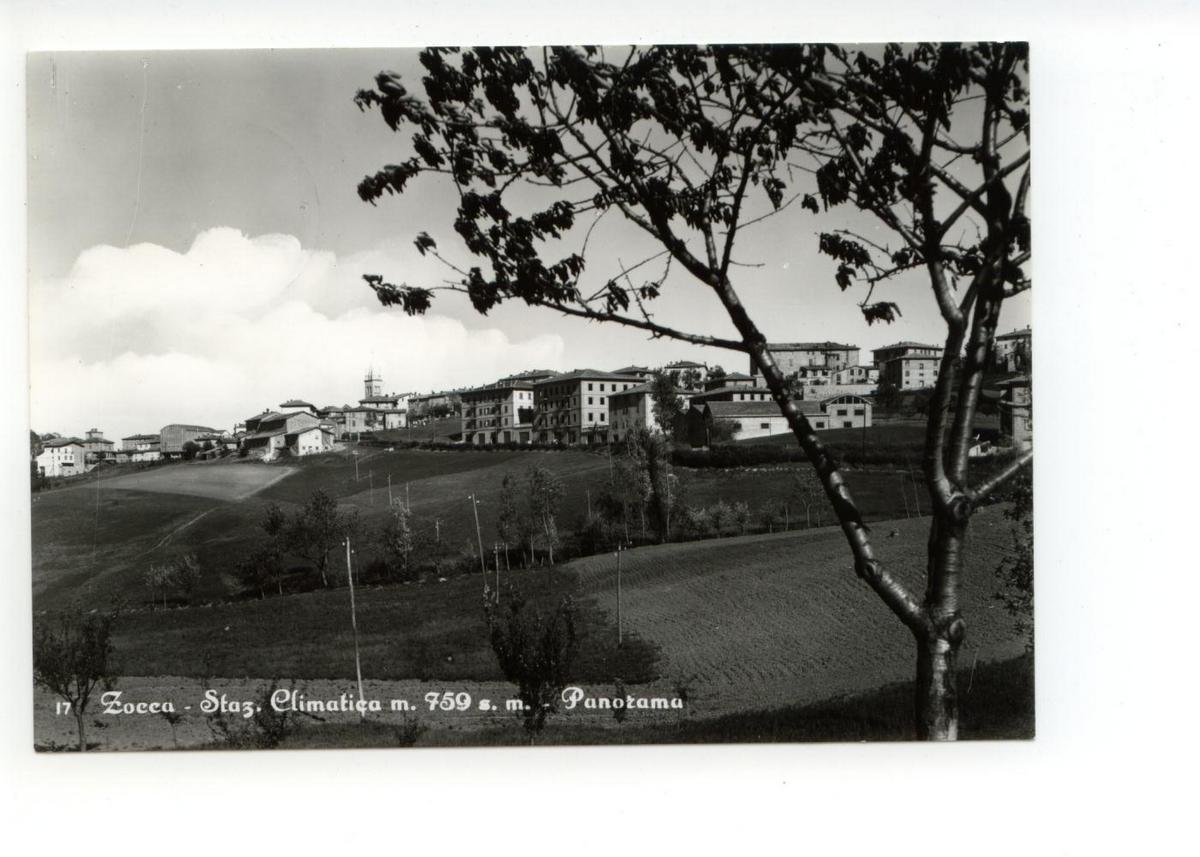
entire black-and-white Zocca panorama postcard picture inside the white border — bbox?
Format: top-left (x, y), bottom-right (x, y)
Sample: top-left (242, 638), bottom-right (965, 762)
top-left (26, 42), bottom-right (1036, 753)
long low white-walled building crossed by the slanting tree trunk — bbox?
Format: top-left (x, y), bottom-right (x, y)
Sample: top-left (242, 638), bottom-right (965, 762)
top-left (688, 395), bottom-right (871, 447)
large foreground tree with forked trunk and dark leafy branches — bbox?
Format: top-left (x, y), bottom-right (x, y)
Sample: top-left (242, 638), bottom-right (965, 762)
top-left (355, 43), bottom-right (1032, 739)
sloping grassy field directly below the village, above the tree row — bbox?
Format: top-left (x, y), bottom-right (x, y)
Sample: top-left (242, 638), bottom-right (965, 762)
top-left (32, 434), bottom-right (955, 610)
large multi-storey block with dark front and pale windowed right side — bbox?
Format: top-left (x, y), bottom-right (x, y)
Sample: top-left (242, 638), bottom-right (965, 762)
top-left (533, 368), bottom-right (642, 444)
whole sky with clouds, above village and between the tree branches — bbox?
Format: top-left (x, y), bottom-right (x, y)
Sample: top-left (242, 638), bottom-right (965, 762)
top-left (28, 49), bottom-right (1030, 438)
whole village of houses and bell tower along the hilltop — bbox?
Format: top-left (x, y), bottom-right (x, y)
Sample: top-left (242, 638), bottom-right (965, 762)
top-left (31, 326), bottom-right (1032, 478)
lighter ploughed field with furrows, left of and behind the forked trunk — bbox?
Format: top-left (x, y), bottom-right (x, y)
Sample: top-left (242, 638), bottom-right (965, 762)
top-left (571, 508), bottom-right (1024, 709)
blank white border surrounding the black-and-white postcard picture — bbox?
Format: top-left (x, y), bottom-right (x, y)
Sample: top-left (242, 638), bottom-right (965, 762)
top-left (0, 0), bottom-right (1200, 855)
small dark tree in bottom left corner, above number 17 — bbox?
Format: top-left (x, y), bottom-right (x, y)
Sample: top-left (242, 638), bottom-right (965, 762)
top-left (34, 612), bottom-right (115, 753)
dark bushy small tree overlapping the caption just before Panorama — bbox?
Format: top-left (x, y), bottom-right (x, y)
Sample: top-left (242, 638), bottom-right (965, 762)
top-left (484, 593), bottom-right (578, 744)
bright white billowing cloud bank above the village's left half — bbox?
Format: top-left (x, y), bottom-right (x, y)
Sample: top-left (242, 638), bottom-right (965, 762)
top-left (30, 228), bottom-right (564, 439)
